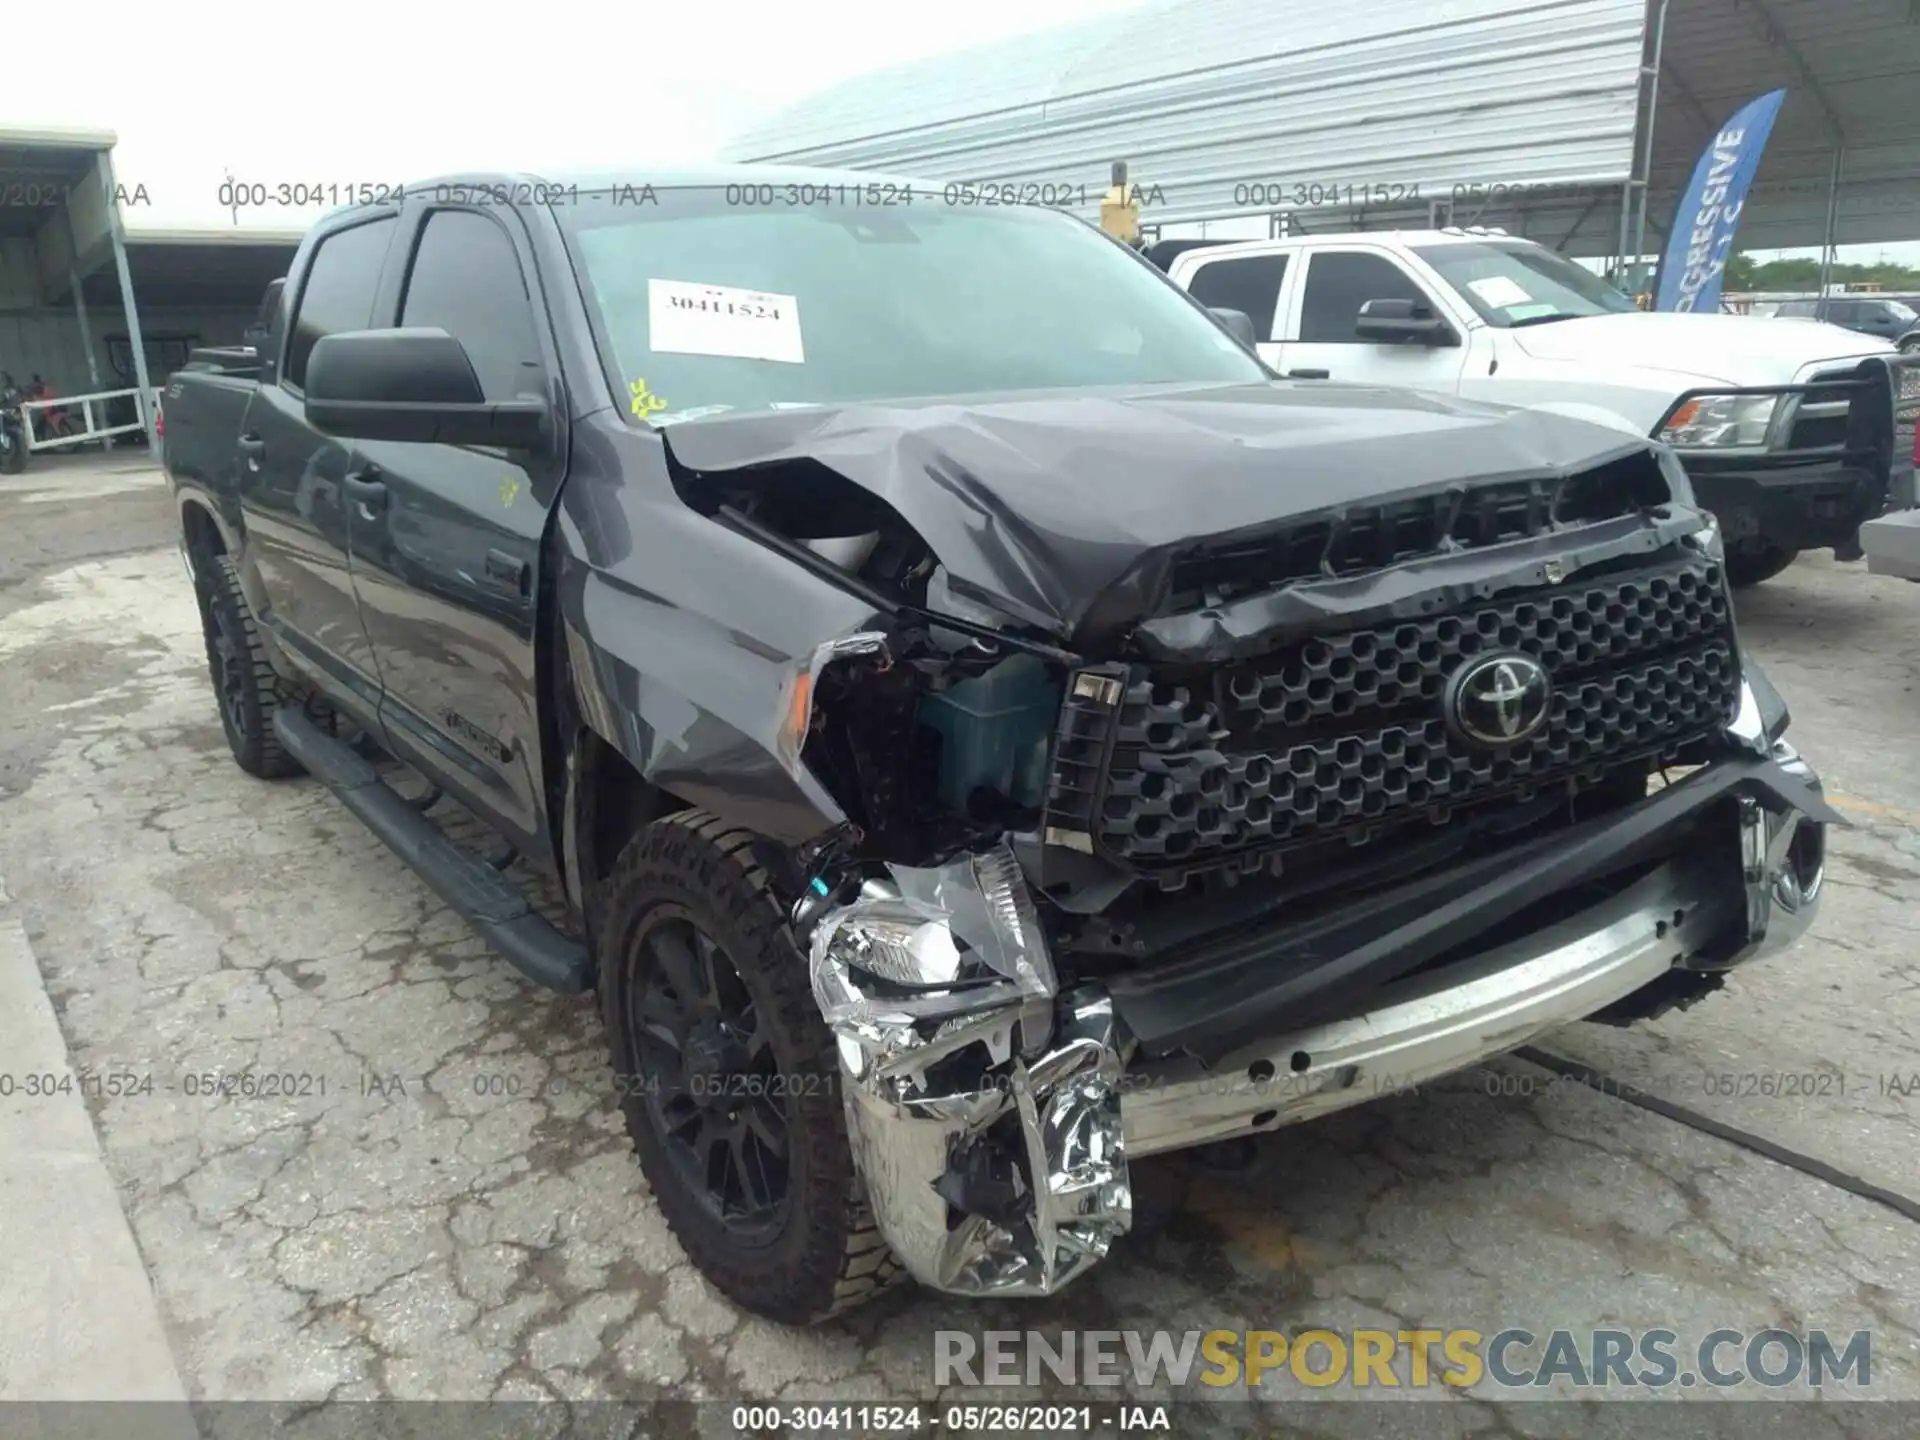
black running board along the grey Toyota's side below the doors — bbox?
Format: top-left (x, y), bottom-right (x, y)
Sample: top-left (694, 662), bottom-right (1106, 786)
top-left (273, 708), bottom-right (593, 995)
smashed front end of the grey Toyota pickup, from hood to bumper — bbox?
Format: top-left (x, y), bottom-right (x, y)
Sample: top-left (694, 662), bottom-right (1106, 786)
top-left (648, 388), bottom-right (1837, 1296)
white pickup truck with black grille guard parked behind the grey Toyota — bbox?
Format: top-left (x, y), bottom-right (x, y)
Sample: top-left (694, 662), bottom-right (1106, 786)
top-left (1148, 230), bottom-right (1920, 586)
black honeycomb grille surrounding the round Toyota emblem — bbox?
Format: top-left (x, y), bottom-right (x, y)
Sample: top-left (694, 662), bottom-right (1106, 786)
top-left (1098, 557), bottom-right (1740, 870)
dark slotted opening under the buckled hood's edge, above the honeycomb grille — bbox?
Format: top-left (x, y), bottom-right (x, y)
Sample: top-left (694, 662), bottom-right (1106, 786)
top-left (1162, 451), bottom-right (1672, 614)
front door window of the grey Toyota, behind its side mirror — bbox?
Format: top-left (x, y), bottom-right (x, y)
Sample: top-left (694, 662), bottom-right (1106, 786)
top-left (399, 209), bottom-right (545, 401)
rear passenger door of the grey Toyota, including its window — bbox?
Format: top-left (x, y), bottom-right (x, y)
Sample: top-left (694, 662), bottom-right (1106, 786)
top-left (238, 213), bottom-right (399, 720)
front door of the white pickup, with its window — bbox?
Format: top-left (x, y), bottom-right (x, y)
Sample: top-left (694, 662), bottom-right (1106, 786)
top-left (1277, 246), bottom-right (1469, 394)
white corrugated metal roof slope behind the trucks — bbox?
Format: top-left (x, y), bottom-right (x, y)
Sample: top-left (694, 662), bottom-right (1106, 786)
top-left (724, 0), bottom-right (1642, 223)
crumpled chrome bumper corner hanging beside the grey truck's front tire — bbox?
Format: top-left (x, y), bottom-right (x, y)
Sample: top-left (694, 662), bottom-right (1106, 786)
top-left (810, 845), bottom-right (1133, 1296)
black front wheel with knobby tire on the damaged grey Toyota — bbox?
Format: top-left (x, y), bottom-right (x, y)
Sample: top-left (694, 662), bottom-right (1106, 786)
top-left (593, 810), bottom-right (902, 1325)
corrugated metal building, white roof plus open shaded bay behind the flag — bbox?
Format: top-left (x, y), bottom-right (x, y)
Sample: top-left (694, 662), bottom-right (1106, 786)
top-left (724, 0), bottom-right (1920, 255)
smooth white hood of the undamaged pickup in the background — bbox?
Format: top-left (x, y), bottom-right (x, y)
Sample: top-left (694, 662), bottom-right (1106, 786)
top-left (1509, 313), bottom-right (1893, 386)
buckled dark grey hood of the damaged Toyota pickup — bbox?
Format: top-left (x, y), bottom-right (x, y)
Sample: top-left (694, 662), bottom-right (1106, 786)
top-left (662, 384), bottom-right (1647, 637)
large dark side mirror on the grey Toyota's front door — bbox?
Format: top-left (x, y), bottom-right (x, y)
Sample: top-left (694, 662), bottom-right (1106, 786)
top-left (305, 328), bottom-right (547, 449)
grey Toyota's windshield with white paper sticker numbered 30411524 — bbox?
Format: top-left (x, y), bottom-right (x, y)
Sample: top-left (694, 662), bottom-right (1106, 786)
top-left (555, 184), bottom-right (1269, 424)
